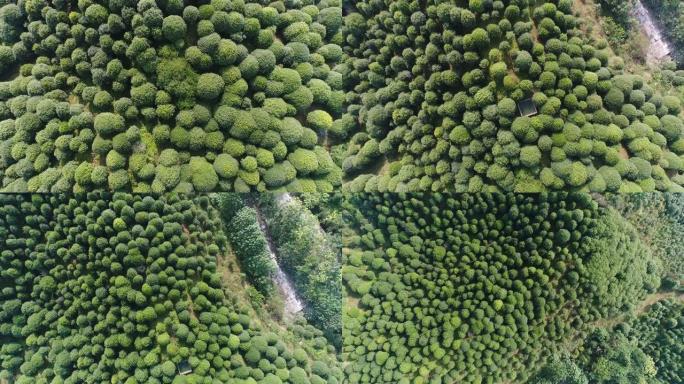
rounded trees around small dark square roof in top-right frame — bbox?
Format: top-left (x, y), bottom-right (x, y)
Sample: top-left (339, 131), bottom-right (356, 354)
top-left (340, 0), bottom-right (684, 192)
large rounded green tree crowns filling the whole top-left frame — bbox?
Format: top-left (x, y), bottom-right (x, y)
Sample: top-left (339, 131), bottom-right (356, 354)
top-left (0, 0), bottom-right (344, 193)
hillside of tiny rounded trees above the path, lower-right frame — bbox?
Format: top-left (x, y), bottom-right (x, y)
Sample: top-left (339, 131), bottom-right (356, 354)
top-left (342, 193), bottom-right (660, 383)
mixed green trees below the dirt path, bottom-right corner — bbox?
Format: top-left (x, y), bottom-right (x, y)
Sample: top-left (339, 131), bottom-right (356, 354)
top-left (528, 300), bottom-right (684, 384)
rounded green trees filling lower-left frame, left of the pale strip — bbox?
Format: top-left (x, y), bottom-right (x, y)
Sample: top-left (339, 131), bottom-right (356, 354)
top-left (0, 193), bottom-right (342, 384)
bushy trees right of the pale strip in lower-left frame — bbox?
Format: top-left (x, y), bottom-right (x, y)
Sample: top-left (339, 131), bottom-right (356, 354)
top-left (260, 194), bottom-right (342, 346)
